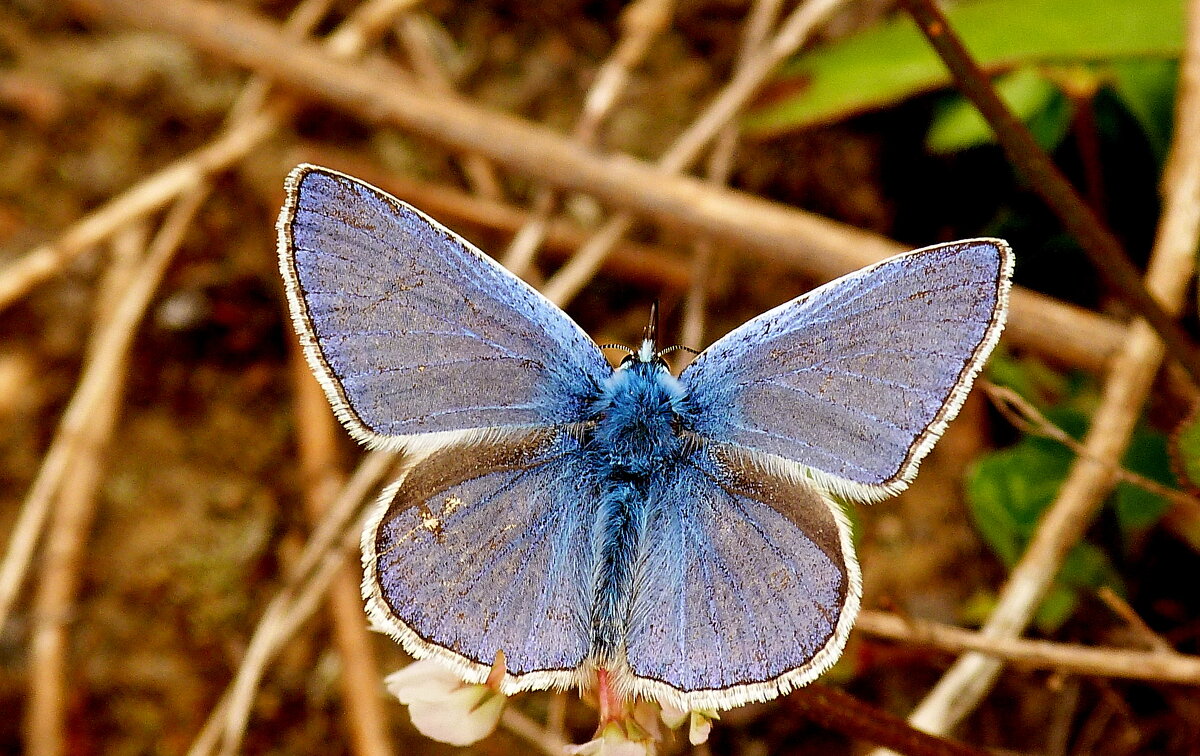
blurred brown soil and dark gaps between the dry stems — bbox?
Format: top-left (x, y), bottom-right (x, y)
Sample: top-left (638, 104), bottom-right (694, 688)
top-left (0, 0), bottom-right (1200, 755)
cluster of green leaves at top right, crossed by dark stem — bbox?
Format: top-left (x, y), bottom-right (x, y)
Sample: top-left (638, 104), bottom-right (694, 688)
top-left (744, 0), bottom-right (1183, 150)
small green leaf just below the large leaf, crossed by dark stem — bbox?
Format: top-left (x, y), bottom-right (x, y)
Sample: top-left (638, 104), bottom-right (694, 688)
top-left (925, 66), bottom-right (1070, 152)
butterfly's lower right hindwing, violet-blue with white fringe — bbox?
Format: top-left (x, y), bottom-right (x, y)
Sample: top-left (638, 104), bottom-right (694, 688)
top-left (626, 445), bottom-right (860, 710)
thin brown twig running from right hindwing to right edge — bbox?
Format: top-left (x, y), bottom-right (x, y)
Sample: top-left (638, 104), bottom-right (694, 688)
top-left (854, 610), bottom-right (1200, 685)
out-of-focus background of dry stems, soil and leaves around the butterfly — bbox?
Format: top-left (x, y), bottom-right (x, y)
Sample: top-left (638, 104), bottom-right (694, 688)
top-left (0, 0), bottom-right (1200, 756)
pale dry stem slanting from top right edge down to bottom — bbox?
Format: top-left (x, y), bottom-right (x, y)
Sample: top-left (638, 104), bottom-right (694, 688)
top-left (883, 0), bottom-right (1200, 748)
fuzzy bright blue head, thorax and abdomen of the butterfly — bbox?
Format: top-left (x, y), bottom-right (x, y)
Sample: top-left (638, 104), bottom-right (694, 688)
top-left (587, 355), bottom-right (689, 664)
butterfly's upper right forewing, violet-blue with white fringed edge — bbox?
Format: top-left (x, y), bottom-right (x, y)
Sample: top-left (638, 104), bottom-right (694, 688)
top-left (679, 239), bottom-right (1013, 499)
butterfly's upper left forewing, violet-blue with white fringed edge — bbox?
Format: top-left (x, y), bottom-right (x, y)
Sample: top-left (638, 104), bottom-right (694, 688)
top-left (278, 166), bottom-right (610, 448)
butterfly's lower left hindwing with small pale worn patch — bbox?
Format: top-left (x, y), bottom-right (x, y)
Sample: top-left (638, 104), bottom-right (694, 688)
top-left (362, 431), bottom-right (596, 692)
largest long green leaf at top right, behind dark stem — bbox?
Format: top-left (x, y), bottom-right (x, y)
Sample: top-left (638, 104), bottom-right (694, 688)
top-left (744, 0), bottom-right (1183, 136)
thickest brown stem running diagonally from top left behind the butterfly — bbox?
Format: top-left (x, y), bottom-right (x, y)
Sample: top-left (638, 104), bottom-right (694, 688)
top-left (68, 0), bottom-right (1122, 370)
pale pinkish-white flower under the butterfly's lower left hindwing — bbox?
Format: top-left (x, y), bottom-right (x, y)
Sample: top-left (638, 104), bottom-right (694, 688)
top-left (384, 659), bottom-right (506, 745)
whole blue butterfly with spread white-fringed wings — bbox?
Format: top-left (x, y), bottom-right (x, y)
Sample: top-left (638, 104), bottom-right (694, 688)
top-left (278, 166), bottom-right (1013, 710)
